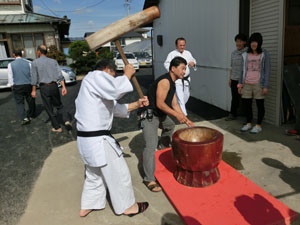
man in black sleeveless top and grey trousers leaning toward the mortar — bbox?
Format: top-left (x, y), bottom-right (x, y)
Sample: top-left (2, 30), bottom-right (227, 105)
top-left (143, 57), bottom-right (194, 192)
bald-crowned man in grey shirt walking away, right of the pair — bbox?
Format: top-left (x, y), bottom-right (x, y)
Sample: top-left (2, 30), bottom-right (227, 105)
top-left (31, 45), bottom-right (72, 133)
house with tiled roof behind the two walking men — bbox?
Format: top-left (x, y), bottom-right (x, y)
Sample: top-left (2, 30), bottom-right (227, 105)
top-left (0, 0), bottom-right (70, 59)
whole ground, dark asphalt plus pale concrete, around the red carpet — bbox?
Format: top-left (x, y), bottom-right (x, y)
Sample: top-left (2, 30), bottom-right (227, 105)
top-left (0, 69), bottom-right (300, 225)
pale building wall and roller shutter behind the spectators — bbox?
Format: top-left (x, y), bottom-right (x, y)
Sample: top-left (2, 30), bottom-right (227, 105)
top-left (144, 0), bottom-right (300, 125)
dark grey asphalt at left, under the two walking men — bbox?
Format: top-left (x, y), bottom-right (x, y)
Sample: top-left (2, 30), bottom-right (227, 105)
top-left (0, 85), bottom-right (79, 225)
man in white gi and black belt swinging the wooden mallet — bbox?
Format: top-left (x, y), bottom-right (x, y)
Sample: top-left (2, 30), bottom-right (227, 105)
top-left (75, 59), bottom-right (149, 217)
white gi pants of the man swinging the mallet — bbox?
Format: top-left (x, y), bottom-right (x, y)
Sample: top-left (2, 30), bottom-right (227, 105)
top-left (81, 142), bottom-right (135, 214)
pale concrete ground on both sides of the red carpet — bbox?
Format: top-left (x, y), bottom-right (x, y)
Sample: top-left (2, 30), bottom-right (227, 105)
top-left (18, 119), bottom-right (300, 225)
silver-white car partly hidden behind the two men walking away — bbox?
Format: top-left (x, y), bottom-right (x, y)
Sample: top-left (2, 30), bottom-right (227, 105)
top-left (0, 58), bottom-right (76, 89)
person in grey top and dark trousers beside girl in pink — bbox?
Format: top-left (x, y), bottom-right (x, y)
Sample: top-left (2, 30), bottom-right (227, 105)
top-left (225, 34), bottom-right (247, 121)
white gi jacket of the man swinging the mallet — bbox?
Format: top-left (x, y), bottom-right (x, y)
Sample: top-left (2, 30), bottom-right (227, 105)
top-left (75, 70), bottom-right (133, 167)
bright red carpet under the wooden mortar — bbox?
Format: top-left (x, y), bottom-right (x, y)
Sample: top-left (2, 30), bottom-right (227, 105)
top-left (155, 148), bottom-right (298, 225)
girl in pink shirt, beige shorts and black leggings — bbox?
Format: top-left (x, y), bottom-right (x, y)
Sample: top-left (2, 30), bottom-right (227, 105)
top-left (238, 33), bottom-right (270, 134)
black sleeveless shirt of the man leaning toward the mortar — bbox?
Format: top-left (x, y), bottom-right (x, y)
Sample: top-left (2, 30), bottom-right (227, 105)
top-left (147, 73), bottom-right (176, 117)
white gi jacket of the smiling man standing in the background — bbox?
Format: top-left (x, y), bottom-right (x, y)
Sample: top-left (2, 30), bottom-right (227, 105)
top-left (164, 49), bottom-right (196, 85)
